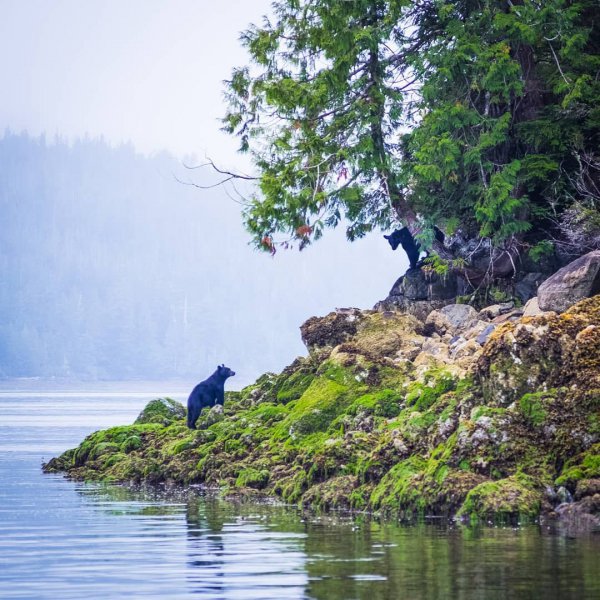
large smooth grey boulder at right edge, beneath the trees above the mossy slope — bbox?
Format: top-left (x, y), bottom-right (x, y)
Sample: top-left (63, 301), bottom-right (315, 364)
top-left (538, 250), bottom-right (600, 313)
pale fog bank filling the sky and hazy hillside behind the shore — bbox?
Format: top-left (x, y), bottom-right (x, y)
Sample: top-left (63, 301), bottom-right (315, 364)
top-left (0, 0), bottom-right (406, 387)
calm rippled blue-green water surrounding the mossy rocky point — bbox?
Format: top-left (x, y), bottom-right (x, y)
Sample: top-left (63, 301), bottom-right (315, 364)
top-left (0, 387), bottom-right (600, 600)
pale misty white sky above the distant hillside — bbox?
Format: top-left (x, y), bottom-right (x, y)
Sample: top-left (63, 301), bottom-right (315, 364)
top-left (0, 0), bottom-right (270, 164)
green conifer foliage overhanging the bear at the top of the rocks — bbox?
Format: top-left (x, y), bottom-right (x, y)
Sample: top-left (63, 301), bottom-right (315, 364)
top-left (224, 0), bottom-right (600, 255)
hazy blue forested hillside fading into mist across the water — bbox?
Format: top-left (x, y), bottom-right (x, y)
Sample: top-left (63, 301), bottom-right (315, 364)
top-left (0, 132), bottom-right (403, 379)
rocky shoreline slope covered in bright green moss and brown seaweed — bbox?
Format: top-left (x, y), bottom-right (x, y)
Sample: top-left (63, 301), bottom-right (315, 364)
top-left (44, 296), bottom-right (600, 522)
